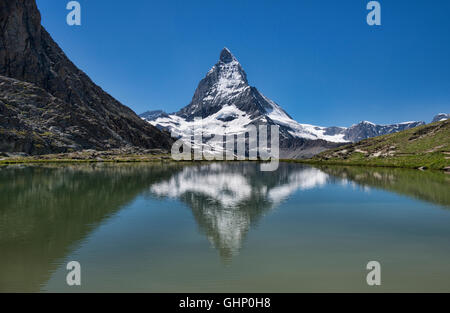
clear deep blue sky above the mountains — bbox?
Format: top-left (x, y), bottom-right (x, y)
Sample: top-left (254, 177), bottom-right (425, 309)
top-left (37, 0), bottom-right (450, 126)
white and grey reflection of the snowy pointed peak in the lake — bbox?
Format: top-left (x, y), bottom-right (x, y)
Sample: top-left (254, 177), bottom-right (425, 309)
top-left (150, 163), bottom-right (328, 260)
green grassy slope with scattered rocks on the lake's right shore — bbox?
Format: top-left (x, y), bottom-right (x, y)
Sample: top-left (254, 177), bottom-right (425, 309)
top-left (309, 120), bottom-right (450, 170)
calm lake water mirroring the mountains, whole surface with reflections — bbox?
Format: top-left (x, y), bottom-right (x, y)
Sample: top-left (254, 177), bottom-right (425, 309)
top-left (0, 163), bottom-right (450, 292)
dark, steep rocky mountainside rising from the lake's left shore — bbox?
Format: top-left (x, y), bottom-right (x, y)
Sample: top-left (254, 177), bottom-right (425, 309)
top-left (0, 0), bottom-right (172, 154)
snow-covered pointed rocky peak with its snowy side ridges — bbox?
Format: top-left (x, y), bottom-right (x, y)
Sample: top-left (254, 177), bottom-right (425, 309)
top-left (141, 48), bottom-right (422, 158)
